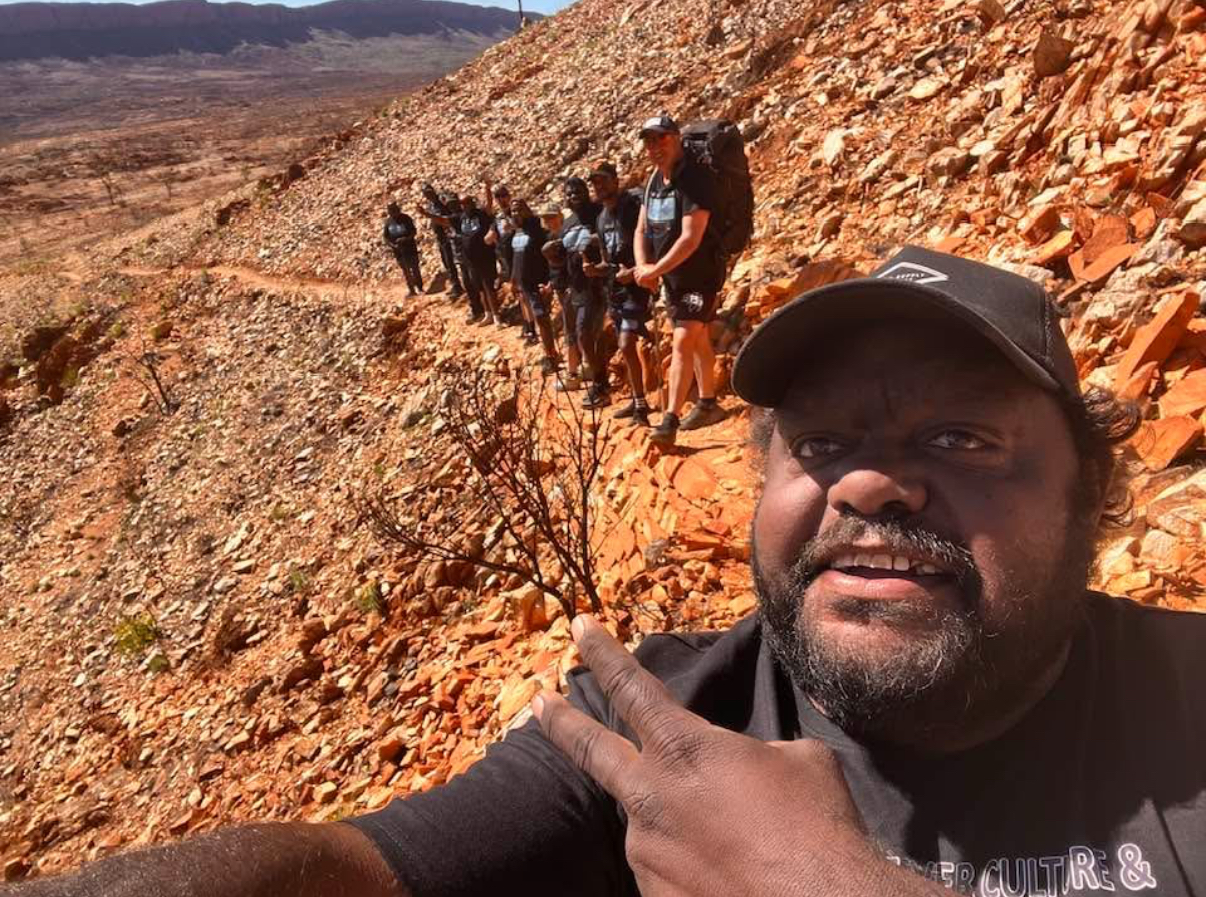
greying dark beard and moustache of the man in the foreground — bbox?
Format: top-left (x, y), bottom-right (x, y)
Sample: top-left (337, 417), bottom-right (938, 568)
top-left (753, 503), bottom-right (1094, 745)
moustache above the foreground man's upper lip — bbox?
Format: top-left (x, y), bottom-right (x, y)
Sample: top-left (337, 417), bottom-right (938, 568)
top-left (791, 514), bottom-right (980, 591)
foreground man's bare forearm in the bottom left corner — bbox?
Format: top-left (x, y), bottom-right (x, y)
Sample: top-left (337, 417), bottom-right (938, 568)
top-left (0, 823), bottom-right (409, 897)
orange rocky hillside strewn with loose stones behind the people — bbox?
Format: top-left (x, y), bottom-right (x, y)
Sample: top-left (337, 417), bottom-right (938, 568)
top-left (0, 0), bottom-right (1206, 877)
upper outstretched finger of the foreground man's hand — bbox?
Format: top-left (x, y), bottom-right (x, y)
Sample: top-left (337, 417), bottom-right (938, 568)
top-left (572, 614), bottom-right (698, 750)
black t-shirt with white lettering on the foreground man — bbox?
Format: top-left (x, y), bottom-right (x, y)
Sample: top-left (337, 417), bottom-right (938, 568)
top-left (352, 594), bottom-right (1206, 897)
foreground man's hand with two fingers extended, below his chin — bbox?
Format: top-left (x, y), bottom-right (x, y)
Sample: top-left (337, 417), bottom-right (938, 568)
top-left (532, 616), bottom-right (944, 897)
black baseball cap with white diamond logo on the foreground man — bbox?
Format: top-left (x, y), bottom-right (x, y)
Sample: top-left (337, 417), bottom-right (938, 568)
top-left (732, 246), bottom-right (1081, 408)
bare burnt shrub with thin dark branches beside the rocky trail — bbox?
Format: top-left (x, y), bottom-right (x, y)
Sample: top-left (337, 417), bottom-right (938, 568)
top-left (353, 367), bottom-right (607, 618)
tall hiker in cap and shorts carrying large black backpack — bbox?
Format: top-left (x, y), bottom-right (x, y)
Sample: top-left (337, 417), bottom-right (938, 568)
top-left (634, 115), bottom-right (753, 445)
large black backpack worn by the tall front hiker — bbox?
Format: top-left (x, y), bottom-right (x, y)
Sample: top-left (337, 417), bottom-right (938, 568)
top-left (683, 118), bottom-right (754, 258)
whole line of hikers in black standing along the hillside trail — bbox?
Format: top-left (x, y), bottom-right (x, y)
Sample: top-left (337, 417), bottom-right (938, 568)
top-left (385, 115), bottom-right (753, 444)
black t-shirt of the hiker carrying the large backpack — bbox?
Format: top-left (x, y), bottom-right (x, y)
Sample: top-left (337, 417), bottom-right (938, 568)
top-left (645, 156), bottom-right (725, 295)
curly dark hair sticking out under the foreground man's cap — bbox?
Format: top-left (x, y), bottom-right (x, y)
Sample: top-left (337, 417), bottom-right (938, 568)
top-left (749, 386), bottom-right (1142, 528)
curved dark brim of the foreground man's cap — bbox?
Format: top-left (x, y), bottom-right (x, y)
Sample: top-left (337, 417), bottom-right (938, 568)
top-left (732, 277), bottom-right (1060, 408)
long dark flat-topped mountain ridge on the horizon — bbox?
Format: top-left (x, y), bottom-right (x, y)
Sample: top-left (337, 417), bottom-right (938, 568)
top-left (0, 0), bottom-right (539, 61)
